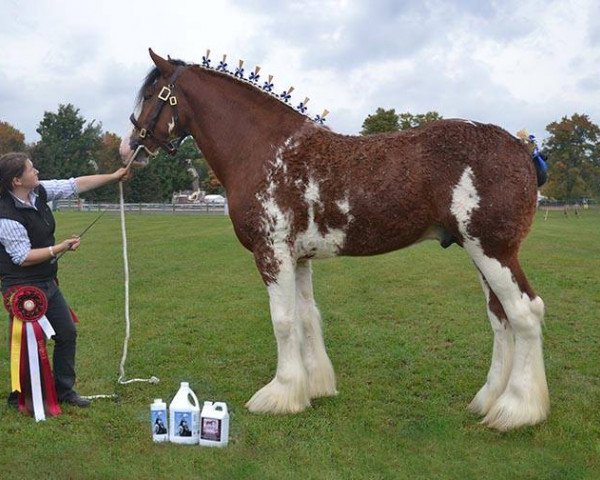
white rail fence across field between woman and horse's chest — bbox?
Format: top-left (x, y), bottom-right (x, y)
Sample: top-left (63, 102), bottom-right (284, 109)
top-left (52, 199), bottom-right (229, 215)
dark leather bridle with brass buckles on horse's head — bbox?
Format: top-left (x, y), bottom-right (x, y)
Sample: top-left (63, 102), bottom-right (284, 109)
top-left (129, 65), bottom-right (188, 155)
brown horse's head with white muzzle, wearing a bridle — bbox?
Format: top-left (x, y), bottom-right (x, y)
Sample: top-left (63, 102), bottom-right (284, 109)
top-left (120, 49), bottom-right (188, 166)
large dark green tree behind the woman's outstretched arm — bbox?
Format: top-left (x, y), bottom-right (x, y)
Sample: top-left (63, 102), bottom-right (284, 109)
top-left (32, 104), bottom-right (102, 178)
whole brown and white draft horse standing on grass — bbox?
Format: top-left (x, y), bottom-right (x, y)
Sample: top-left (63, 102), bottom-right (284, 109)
top-left (121, 51), bottom-right (549, 430)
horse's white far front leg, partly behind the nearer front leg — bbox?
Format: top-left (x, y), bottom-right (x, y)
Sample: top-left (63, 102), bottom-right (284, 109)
top-left (296, 260), bottom-right (337, 398)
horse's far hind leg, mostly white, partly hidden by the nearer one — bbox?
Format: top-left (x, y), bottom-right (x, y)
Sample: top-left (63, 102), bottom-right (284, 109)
top-left (469, 273), bottom-right (515, 415)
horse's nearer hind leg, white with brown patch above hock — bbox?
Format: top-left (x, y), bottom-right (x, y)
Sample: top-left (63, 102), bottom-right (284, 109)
top-left (465, 249), bottom-right (550, 430)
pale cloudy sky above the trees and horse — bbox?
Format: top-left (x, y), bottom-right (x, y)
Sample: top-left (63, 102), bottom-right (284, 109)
top-left (0, 0), bottom-right (600, 143)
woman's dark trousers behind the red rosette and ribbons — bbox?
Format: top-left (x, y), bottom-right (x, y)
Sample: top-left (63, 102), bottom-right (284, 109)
top-left (2, 280), bottom-right (77, 400)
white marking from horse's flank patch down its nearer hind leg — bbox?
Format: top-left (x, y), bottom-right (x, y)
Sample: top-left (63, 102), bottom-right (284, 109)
top-left (450, 167), bottom-right (550, 430)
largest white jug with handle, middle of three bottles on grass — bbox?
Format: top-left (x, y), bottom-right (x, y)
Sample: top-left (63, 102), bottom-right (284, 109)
top-left (169, 382), bottom-right (200, 445)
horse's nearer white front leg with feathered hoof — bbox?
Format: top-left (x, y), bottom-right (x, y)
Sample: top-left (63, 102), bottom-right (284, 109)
top-left (246, 256), bottom-right (310, 413)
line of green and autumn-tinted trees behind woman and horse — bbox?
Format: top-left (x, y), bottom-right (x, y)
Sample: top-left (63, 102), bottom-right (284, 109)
top-left (0, 104), bottom-right (600, 202)
